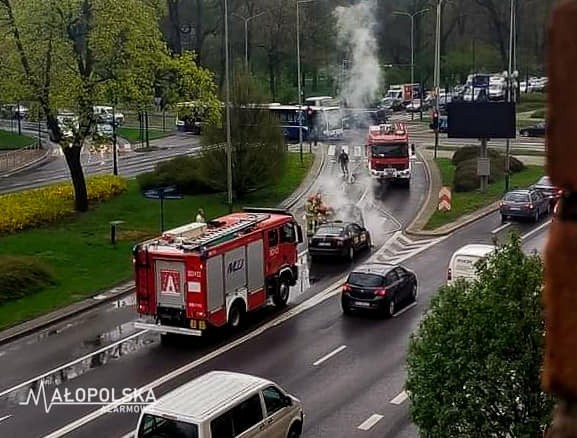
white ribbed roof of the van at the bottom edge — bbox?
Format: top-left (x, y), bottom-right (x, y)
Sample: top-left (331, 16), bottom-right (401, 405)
top-left (143, 371), bottom-right (274, 424)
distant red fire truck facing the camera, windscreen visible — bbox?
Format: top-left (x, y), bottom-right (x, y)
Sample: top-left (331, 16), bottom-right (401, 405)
top-left (366, 123), bottom-right (414, 187)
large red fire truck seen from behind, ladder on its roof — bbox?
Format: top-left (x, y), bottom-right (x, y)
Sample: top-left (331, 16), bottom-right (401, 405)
top-left (133, 209), bottom-right (303, 339)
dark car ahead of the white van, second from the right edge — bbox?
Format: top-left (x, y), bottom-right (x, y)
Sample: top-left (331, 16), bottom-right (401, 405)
top-left (499, 189), bottom-right (551, 222)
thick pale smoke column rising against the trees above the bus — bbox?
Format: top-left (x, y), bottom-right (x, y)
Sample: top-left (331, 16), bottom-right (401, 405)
top-left (334, 0), bottom-right (381, 108)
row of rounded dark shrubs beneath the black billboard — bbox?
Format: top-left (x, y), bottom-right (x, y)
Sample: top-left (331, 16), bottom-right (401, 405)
top-left (452, 146), bottom-right (525, 192)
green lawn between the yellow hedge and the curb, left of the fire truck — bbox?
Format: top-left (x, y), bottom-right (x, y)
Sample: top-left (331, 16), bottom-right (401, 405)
top-left (0, 154), bottom-right (313, 328)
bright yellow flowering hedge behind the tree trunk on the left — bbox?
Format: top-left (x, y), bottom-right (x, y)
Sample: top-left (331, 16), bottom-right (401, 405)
top-left (0, 175), bottom-right (126, 234)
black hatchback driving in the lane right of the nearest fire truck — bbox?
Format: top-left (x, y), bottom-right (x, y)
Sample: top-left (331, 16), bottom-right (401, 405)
top-left (341, 263), bottom-right (418, 317)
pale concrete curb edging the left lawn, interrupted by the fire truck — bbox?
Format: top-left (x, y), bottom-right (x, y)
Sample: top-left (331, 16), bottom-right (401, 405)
top-left (0, 147), bottom-right (326, 345)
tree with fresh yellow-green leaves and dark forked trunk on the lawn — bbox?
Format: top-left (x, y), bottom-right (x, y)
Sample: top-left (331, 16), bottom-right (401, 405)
top-left (0, 0), bottom-right (218, 211)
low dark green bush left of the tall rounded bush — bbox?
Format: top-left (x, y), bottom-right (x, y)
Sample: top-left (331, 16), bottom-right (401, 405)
top-left (136, 157), bottom-right (216, 195)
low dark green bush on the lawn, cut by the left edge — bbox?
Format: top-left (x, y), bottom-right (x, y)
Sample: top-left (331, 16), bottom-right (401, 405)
top-left (0, 256), bottom-right (55, 304)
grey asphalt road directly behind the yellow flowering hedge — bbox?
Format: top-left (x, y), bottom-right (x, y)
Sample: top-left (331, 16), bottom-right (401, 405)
top-left (0, 134), bottom-right (199, 193)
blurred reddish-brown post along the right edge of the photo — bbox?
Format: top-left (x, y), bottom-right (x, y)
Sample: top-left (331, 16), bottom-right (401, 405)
top-left (542, 0), bottom-right (577, 438)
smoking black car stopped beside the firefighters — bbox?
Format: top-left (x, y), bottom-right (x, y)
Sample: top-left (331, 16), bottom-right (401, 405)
top-left (309, 221), bottom-right (371, 261)
